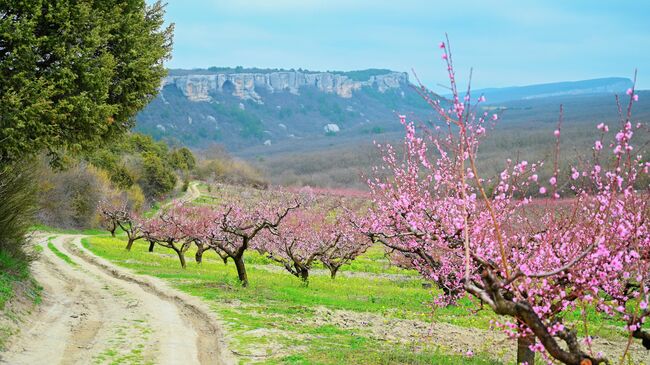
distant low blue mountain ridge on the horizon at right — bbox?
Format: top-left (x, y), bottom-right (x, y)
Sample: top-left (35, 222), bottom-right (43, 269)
top-left (460, 77), bottom-right (632, 104)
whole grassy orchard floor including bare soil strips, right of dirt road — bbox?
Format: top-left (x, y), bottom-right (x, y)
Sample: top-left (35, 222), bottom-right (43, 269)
top-left (76, 185), bottom-right (636, 364)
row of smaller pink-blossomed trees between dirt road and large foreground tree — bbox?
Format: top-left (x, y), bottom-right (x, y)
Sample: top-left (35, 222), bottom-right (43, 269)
top-left (101, 189), bottom-right (370, 286)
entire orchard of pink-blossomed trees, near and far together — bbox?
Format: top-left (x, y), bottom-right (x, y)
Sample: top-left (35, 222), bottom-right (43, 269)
top-left (102, 41), bottom-right (650, 365)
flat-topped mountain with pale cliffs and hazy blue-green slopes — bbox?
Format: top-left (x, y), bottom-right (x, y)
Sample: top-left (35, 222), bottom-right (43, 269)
top-left (136, 67), bottom-right (433, 153)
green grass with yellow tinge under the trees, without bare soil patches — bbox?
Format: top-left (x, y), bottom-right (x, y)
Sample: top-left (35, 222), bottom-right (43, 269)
top-left (82, 236), bottom-right (506, 364)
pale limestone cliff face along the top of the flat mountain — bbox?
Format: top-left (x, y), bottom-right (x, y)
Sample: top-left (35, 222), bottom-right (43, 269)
top-left (162, 71), bottom-right (408, 103)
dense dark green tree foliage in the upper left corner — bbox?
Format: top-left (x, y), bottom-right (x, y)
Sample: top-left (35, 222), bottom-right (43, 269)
top-left (0, 0), bottom-right (172, 164)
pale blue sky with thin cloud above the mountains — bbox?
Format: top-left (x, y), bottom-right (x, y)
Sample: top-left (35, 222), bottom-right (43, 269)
top-left (156, 0), bottom-right (650, 91)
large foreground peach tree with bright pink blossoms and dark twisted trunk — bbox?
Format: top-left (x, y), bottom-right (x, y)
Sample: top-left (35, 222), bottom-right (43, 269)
top-left (363, 34), bottom-right (650, 365)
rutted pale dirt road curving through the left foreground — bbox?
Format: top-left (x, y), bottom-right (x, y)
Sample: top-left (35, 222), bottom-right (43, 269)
top-left (0, 235), bottom-right (234, 365)
